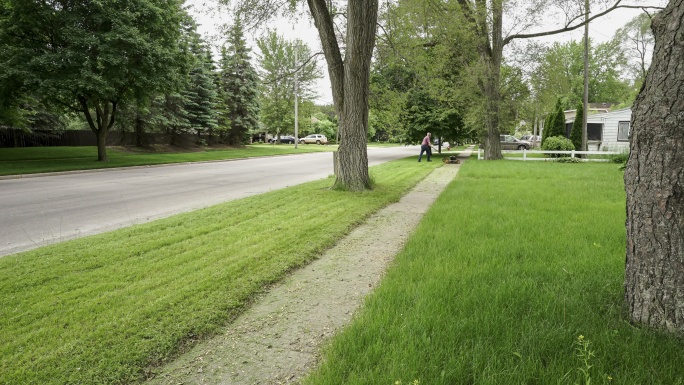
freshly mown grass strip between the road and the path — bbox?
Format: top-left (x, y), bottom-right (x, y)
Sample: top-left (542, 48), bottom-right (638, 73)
top-left (0, 157), bottom-right (441, 385)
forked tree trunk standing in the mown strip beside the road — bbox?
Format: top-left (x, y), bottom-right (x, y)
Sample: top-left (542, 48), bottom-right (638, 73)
top-left (308, 0), bottom-right (378, 191)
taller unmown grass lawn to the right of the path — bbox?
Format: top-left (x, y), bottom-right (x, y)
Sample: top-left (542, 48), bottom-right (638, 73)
top-left (305, 161), bottom-right (684, 385)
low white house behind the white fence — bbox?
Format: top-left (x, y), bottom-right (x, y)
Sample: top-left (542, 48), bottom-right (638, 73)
top-left (565, 108), bottom-right (632, 151)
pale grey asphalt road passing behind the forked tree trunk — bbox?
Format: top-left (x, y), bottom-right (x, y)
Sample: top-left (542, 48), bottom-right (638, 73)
top-left (0, 146), bottom-right (420, 256)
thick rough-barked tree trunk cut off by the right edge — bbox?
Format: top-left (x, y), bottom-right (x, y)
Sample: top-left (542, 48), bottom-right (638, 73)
top-left (625, 0), bottom-right (684, 333)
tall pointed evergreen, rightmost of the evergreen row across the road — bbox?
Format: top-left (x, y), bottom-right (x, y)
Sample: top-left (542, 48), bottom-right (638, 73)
top-left (220, 18), bottom-right (259, 144)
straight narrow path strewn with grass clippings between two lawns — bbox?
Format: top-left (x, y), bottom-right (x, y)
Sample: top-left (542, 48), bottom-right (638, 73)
top-left (148, 151), bottom-right (469, 385)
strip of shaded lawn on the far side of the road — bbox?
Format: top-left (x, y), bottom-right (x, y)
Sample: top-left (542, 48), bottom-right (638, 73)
top-left (0, 144), bottom-right (337, 175)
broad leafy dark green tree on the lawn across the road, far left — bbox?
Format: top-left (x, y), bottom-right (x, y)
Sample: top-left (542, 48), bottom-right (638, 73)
top-left (0, 0), bottom-right (188, 161)
